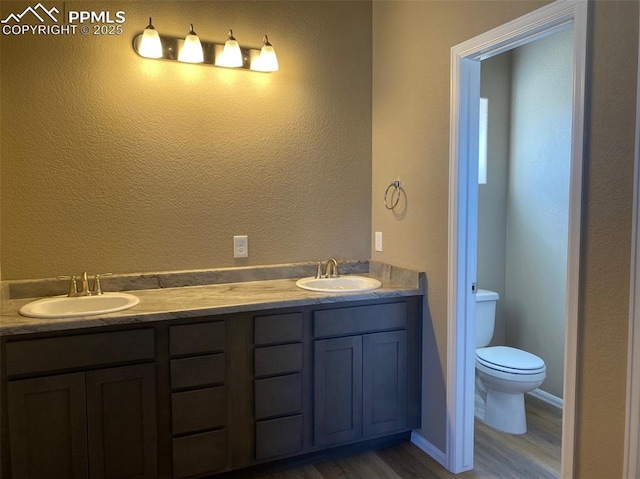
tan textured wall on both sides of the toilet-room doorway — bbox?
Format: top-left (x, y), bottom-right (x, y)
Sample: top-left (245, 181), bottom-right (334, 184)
top-left (372, 1), bottom-right (638, 479)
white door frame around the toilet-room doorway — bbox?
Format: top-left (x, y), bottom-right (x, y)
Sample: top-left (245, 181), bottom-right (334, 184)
top-left (446, 0), bottom-right (588, 479)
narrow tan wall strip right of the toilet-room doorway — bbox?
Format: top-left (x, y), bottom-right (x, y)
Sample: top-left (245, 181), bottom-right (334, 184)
top-left (576, 1), bottom-right (638, 479)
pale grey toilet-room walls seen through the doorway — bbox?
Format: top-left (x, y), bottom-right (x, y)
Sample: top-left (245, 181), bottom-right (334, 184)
top-left (477, 28), bottom-right (573, 408)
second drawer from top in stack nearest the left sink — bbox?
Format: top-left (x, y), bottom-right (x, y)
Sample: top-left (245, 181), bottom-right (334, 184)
top-left (171, 354), bottom-right (225, 389)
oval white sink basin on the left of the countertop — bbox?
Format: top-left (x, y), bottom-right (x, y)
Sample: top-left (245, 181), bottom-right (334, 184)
top-left (20, 293), bottom-right (140, 318)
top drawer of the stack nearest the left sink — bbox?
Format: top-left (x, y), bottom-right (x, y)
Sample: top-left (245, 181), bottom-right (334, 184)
top-left (169, 321), bottom-right (225, 356)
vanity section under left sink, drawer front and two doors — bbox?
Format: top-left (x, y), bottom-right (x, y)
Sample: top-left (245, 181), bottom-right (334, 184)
top-left (5, 329), bottom-right (157, 479)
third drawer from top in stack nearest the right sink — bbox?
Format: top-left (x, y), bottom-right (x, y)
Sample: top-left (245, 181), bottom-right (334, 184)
top-left (254, 374), bottom-right (302, 419)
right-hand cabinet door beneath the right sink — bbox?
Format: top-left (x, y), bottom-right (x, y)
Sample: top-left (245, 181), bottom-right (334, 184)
top-left (362, 331), bottom-right (408, 437)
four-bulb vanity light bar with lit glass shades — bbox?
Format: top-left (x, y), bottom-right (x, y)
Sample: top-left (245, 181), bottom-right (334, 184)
top-left (133, 18), bottom-right (279, 72)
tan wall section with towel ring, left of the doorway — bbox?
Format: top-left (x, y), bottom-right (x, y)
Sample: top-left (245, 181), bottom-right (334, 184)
top-left (372, 0), bottom-right (548, 451)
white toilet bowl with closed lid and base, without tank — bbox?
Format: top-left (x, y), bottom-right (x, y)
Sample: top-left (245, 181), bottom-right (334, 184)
top-left (476, 346), bottom-right (546, 434)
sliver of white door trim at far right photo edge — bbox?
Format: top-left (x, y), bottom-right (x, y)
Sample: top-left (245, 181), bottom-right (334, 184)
top-left (623, 15), bottom-right (640, 479)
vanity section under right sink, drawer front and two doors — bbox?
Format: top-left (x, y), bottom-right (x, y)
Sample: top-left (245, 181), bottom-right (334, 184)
top-left (313, 302), bottom-right (417, 446)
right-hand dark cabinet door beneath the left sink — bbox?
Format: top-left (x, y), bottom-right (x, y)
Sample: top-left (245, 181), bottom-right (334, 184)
top-left (85, 364), bottom-right (157, 479)
